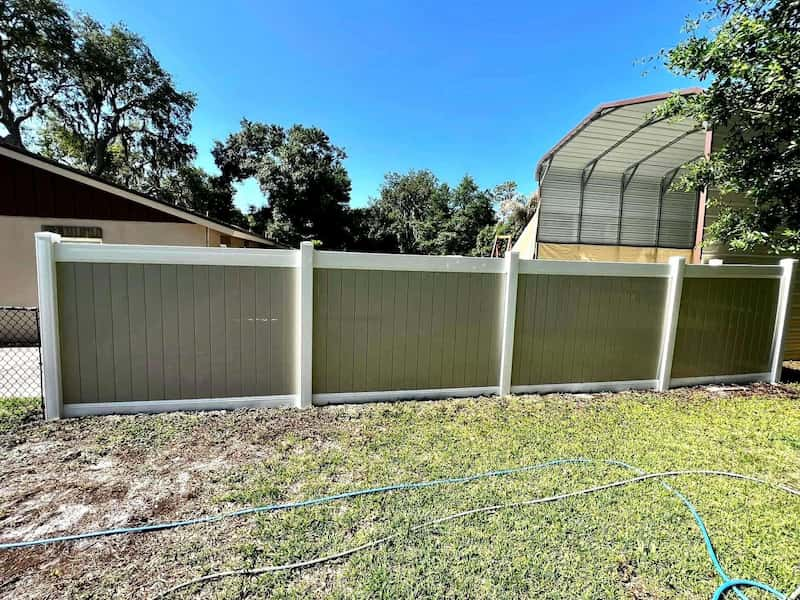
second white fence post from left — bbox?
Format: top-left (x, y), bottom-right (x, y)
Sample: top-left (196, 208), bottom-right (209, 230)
top-left (297, 242), bottom-right (314, 408)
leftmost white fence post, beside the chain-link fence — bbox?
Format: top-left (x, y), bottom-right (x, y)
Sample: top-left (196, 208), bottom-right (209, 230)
top-left (35, 232), bottom-right (61, 421)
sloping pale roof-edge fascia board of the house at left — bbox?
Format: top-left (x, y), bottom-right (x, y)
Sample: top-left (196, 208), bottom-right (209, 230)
top-left (0, 146), bottom-right (272, 244)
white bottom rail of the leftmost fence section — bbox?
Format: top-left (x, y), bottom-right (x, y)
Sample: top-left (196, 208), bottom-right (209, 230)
top-left (63, 394), bottom-right (296, 417)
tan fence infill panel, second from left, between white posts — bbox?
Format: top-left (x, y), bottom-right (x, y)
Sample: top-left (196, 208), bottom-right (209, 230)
top-left (312, 269), bottom-right (502, 393)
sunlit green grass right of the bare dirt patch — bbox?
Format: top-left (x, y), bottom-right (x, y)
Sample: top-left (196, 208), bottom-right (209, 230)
top-left (198, 394), bottom-right (800, 598)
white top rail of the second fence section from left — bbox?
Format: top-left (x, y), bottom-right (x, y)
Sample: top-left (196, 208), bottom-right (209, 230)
top-left (314, 251), bottom-right (505, 273)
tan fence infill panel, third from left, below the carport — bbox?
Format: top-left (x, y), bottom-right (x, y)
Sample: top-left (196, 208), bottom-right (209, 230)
top-left (511, 275), bottom-right (666, 385)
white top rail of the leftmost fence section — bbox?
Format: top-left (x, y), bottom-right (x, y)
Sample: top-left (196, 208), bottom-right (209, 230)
top-left (55, 243), bottom-right (298, 268)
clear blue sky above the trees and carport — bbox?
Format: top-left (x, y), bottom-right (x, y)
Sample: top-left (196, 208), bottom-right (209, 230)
top-left (67, 0), bottom-right (703, 207)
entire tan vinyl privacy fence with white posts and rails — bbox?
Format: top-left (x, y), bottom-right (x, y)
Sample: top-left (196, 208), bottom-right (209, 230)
top-left (36, 233), bottom-right (795, 419)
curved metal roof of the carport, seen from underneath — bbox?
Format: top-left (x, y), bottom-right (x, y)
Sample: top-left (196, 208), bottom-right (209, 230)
top-left (536, 88), bottom-right (705, 182)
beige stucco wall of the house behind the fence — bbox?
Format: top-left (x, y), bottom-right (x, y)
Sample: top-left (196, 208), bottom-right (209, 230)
top-left (0, 217), bottom-right (212, 306)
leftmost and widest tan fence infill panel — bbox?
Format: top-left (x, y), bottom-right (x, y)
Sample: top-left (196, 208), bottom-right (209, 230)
top-left (57, 263), bottom-right (295, 404)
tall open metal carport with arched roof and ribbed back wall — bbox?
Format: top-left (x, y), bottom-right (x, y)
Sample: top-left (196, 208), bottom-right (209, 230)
top-left (536, 88), bottom-right (706, 248)
